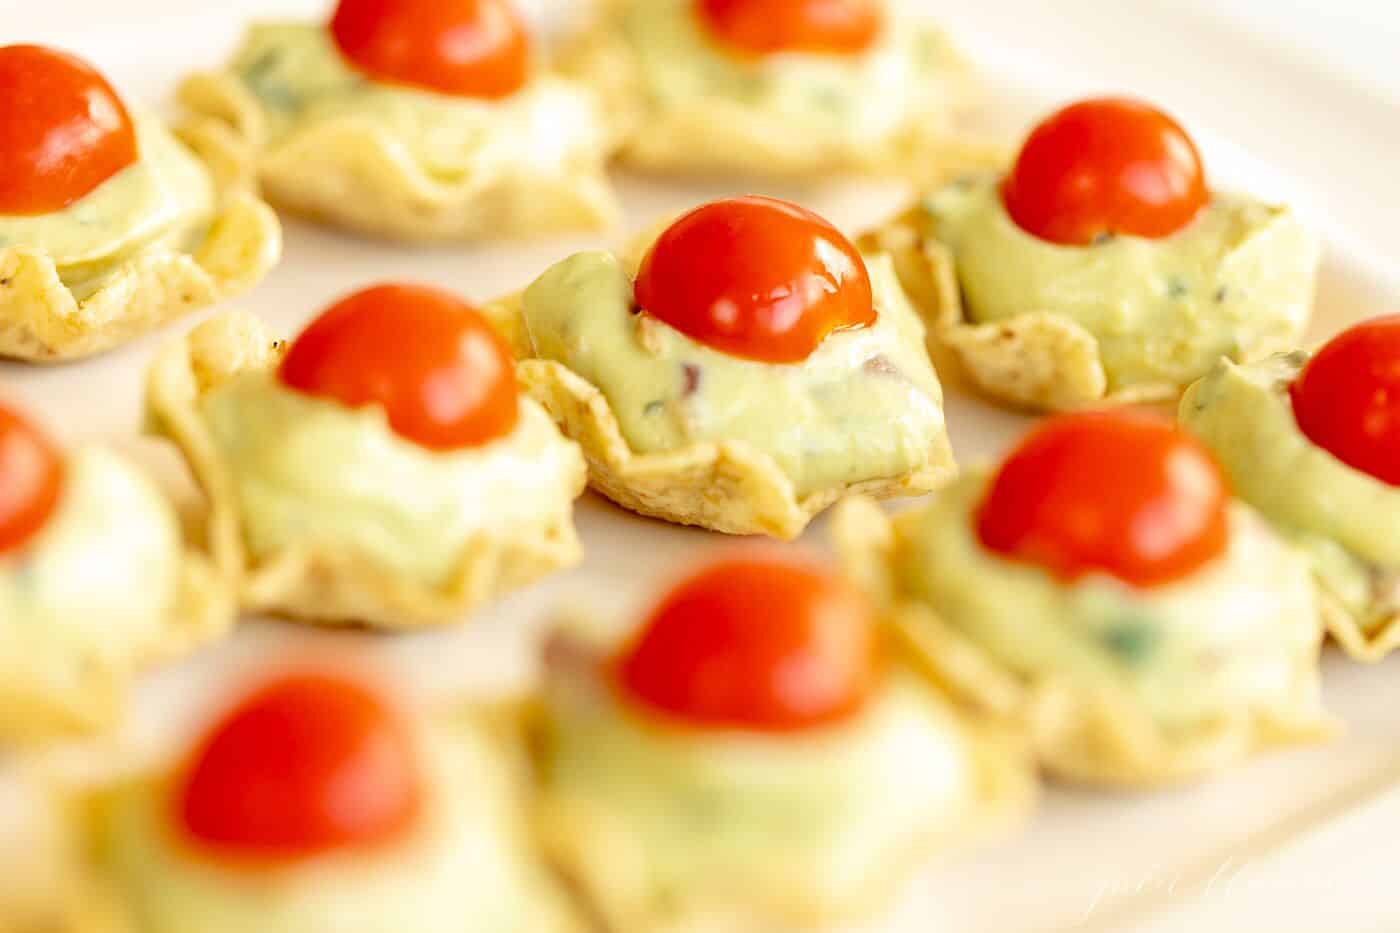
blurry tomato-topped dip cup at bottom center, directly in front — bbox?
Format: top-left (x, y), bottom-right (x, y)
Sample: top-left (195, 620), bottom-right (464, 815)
top-left (535, 555), bottom-right (1033, 933)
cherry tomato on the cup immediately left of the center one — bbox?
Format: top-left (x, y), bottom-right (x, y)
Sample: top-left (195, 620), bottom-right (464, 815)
top-left (280, 284), bottom-right (519, 451)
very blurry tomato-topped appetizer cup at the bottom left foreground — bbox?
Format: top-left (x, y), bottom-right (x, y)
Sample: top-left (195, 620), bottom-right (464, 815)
top-left (88, 672), bottom-right (582, 933)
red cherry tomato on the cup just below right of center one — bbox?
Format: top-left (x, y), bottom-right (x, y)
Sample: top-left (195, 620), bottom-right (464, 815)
top-left (976, 412), bottom-right (1229, 587)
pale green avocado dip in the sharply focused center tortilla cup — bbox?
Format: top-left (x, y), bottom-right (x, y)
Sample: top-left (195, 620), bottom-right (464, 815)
top-left (524, 246), bottom-right (945, 496)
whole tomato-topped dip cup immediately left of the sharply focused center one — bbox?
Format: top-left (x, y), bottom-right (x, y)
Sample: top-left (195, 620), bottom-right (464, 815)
top-left (147, 286), bottom-right (587, 628)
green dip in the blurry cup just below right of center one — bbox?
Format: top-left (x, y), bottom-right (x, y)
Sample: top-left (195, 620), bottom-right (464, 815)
top-left (893, 472), bottom-right (1320, 730)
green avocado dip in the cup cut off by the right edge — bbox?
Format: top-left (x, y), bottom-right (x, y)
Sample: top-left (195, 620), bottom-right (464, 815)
top-left (1180, 350), bottom-right (1400, 628)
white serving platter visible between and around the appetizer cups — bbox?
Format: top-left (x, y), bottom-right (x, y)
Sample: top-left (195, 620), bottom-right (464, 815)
top-left (0, 0), bottom-right (1400, 933)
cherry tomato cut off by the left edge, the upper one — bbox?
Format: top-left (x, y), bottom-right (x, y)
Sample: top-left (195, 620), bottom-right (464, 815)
top-left (0, 45), bottom-right (137, 214)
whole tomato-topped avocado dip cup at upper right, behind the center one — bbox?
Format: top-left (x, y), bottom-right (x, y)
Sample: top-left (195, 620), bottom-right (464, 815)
top-left (862, 99), bottom-right (1319, 409)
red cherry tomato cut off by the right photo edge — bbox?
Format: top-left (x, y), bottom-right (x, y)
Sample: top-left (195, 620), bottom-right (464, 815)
top-left (1289, 314), bottom-right (1400, 486)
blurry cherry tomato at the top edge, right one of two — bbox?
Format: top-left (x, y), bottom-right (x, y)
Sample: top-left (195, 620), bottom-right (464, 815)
top-left (696, 0), bottom-right (885, 55)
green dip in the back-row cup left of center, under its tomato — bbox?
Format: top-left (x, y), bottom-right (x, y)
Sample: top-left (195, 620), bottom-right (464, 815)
top-left (232, 24), bottom-right (602, 182)
